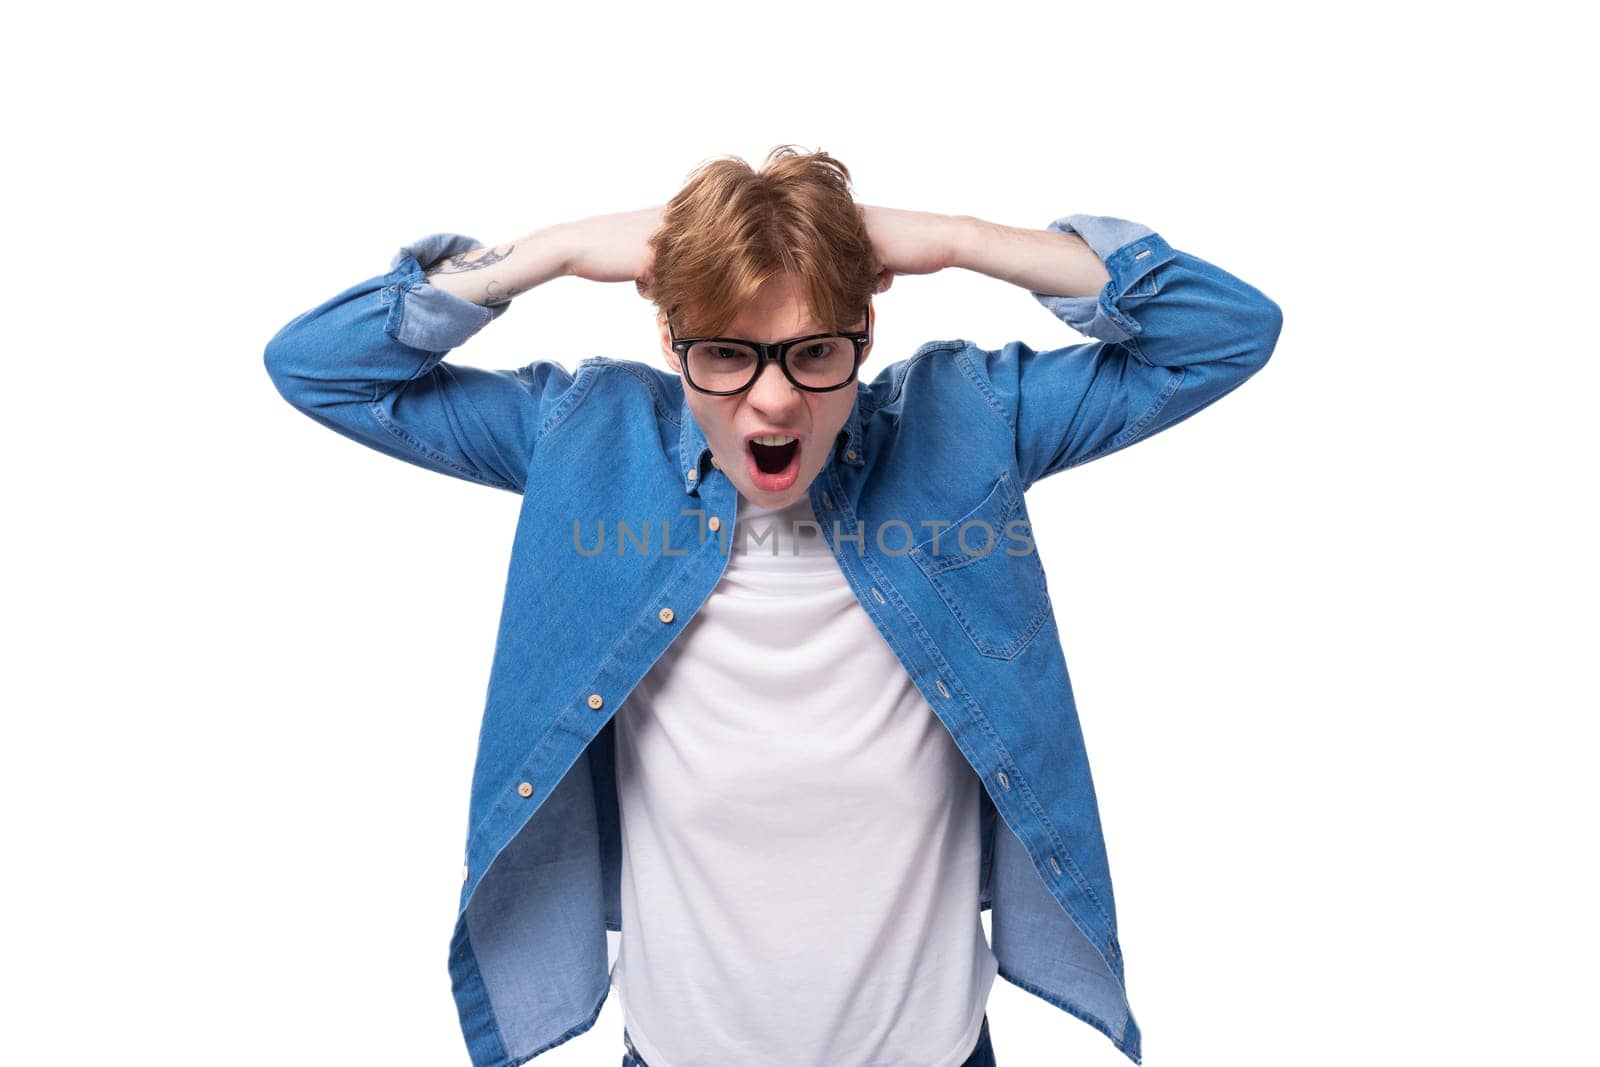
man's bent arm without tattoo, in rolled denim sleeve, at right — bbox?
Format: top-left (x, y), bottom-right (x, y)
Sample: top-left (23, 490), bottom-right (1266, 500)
top-left (947, 214), bottom-right (1283, 488)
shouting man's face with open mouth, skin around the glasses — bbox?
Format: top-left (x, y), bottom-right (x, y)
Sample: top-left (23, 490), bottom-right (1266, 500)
top-left (656, 275), bottom-right (877, 509)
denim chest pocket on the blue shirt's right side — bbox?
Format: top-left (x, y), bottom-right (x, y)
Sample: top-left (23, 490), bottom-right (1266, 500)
top-left (910, 470), bottom-right (1050, 659)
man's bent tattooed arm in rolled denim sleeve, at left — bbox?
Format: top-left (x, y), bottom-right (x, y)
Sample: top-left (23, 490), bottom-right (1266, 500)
top-left (264, 226), bottom-right (592, 493)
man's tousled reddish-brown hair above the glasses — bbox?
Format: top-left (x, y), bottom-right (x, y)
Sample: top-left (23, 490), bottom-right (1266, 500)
top-left (640, 144), bottom-right (877, 338)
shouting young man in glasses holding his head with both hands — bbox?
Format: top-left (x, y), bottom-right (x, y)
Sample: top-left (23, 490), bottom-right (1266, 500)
top-left (266, 147), bottom-right (1282, 1067)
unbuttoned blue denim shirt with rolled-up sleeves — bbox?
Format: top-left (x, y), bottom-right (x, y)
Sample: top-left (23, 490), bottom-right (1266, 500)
top-left (266, 214), bottom-right (1282, 1067)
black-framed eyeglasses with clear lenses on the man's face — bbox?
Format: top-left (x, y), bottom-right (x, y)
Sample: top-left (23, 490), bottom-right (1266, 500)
top-left (667, 306), bottom-right (872, 397)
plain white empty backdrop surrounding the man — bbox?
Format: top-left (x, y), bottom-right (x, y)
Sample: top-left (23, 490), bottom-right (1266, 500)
top-left (0, 2), bottom-right (1600, 1067)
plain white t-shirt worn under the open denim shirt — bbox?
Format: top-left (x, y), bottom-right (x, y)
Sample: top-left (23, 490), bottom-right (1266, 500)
top-left (611, 496), bottom-right (997, 1067)
